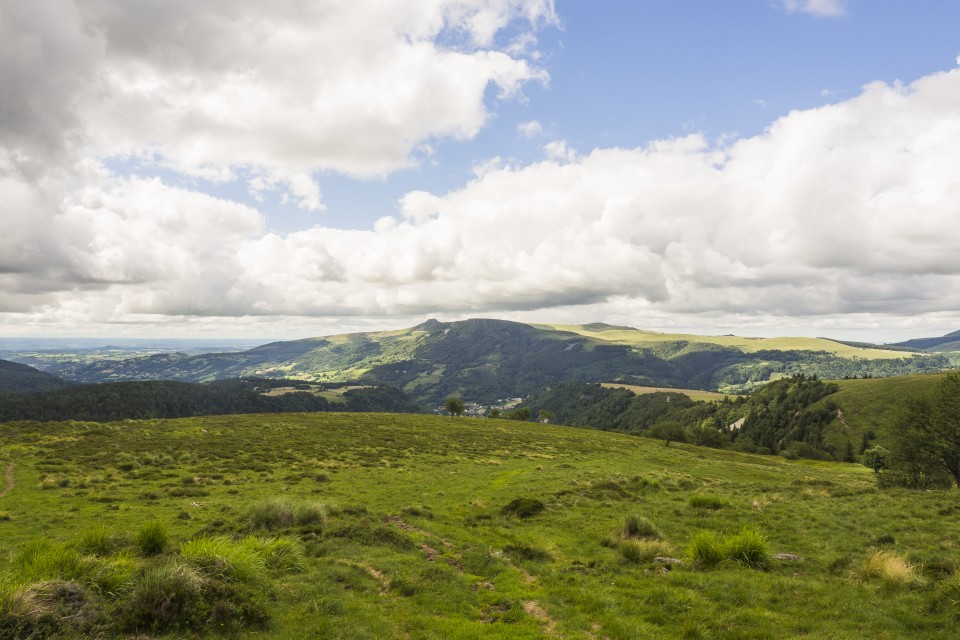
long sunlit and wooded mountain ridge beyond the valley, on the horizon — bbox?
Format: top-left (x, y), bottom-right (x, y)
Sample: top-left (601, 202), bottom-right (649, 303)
top-left (5, 319), bottom-right (951, 405)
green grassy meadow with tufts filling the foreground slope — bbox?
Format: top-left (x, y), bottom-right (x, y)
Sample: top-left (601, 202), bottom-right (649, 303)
top-left (0, 414), bottom-right (960, 640)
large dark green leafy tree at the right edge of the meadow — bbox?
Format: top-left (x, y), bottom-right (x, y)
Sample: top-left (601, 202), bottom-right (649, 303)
top-left (890, 373), bottom-right (960, 488)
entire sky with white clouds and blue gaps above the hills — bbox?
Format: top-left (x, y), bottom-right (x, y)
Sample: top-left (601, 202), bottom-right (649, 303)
top-left (0, 0), bottom-right (960, 342)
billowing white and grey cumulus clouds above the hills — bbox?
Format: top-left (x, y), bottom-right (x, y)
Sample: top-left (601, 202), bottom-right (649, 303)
top-left (0, 5), bottom-right (960, 338)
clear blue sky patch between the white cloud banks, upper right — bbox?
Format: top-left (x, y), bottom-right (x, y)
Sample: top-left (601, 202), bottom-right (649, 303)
top-left (260, 0), bottom-right (960, 231)
